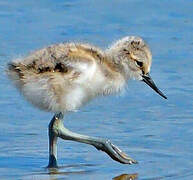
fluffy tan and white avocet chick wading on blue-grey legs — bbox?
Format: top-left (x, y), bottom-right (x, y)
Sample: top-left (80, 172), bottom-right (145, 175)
top-left (7, 36), bottom-right (166, 167)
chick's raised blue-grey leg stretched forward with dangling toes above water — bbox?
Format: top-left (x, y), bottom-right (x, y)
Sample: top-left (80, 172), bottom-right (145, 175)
top-left (49, 113), bottom-right (137, 164)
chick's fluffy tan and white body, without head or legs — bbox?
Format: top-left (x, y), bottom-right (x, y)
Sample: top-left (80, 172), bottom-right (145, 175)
top-left (9, 43), bottom-right (126, 112)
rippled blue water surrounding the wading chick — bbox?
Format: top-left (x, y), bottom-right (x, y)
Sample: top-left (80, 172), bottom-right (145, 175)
top-left (0, 0), bottom-right (193, 180)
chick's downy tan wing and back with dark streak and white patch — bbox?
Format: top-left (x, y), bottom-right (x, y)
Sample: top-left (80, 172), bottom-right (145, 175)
top-left (9, 43), bottom-right (103, 83)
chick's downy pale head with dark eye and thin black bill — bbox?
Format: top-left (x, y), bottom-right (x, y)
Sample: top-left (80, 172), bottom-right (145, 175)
top-left (108, 36), bottom-right (167, 99)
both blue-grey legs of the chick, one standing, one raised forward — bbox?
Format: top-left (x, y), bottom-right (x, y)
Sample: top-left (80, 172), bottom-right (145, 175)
top-left (48, 113), bottom-right (137, 167)
